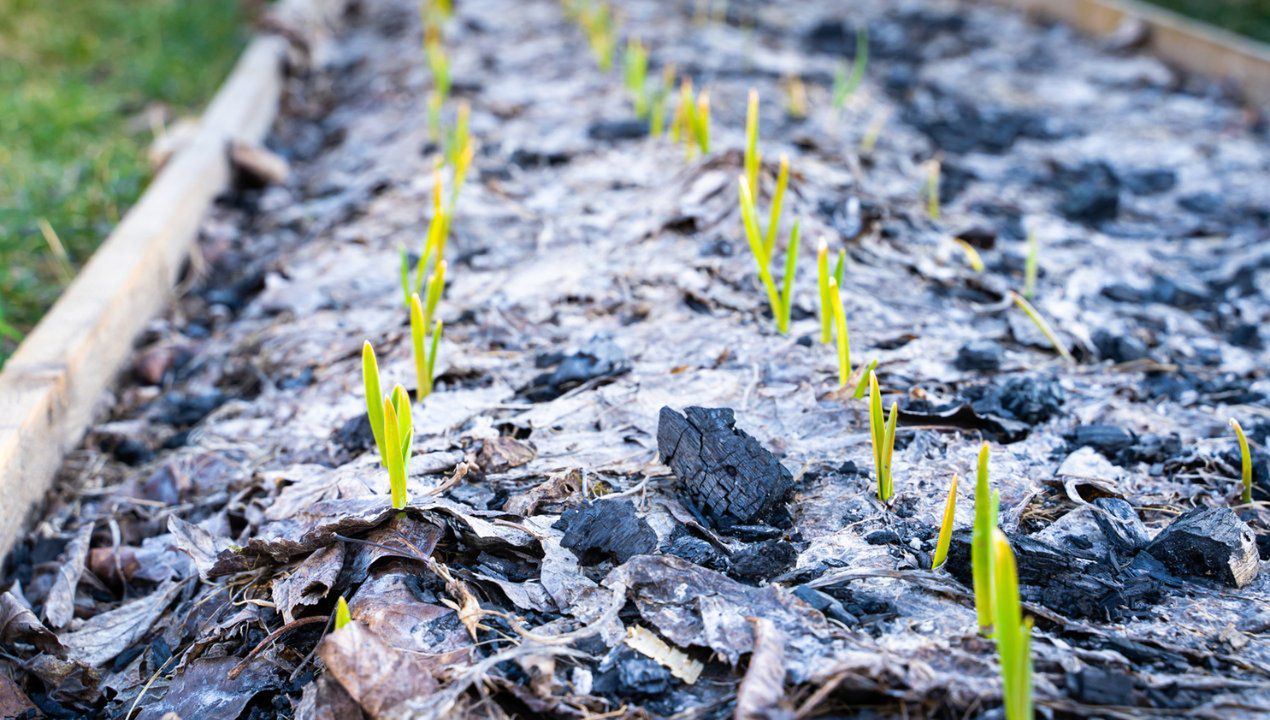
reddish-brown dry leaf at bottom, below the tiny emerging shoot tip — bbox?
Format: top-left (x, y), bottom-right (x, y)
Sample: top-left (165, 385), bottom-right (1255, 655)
top-left (318, 621), bottom-right (437, 717)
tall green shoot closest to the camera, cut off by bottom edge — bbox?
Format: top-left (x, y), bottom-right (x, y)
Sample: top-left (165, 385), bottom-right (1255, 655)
top-left (992, 530), bottom-right (1035, 720)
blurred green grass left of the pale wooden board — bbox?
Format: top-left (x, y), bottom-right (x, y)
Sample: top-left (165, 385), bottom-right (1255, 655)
top-left (0, 0), bottom-right (248, 363)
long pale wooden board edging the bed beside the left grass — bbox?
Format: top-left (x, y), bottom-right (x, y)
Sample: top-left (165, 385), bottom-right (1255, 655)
top-left (0, 34), bottom-right (288, 556)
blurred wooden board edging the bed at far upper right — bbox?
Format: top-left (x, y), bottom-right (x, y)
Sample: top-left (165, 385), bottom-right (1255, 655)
top-left (996, 0), bottom-right (1270, 110)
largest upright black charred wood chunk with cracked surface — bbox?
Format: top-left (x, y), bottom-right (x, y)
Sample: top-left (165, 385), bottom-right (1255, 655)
top-left (657, 408), bottom-right (794, 527)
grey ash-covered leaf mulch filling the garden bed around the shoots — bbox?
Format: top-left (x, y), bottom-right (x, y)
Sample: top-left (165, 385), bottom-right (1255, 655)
top-left (0, 0), bottom-right (1270, 720)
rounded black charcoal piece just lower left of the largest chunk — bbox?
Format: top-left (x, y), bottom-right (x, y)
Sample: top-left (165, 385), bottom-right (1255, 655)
top-left (552, 498), bottom-right (657, 565)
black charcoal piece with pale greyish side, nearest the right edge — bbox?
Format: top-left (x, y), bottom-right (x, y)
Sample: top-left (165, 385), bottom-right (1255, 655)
top-left (1146, 508), bottom-right (1261, 588)
